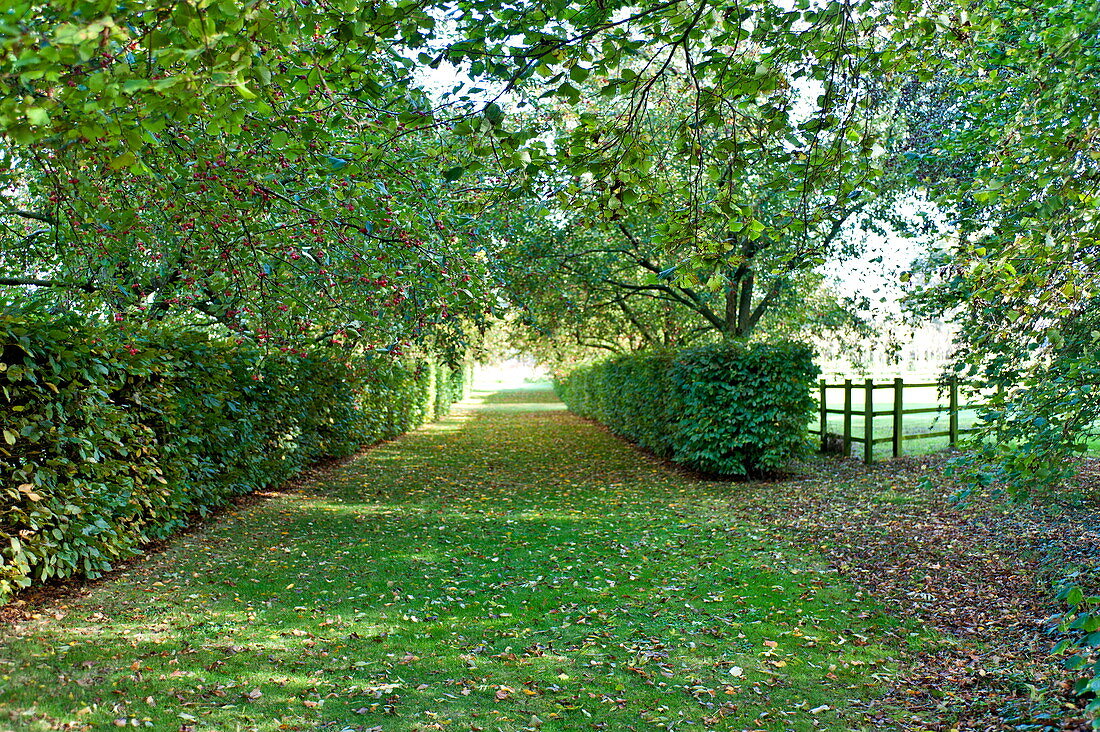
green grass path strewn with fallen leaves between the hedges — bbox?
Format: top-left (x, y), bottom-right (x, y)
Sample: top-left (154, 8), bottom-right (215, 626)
top-left (0, 390), bottom-right (927, 732)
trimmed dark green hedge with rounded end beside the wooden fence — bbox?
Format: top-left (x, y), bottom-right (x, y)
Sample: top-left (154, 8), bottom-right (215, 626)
top-left (554, 342), bottom-right (820, 477)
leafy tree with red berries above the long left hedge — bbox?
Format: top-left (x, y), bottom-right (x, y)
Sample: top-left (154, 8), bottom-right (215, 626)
top-left (0, 1), bottom-right (503, 345)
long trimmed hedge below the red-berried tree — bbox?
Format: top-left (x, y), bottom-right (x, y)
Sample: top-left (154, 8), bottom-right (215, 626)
top-left (0, 314), bottom-right (463, 599)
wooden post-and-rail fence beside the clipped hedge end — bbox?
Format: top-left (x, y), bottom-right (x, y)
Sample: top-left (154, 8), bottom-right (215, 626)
top-left (810, 379), bottom-right (980, 463)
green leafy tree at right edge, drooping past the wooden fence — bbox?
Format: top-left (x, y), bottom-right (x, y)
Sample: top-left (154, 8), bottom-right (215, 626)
top-left (906, 2), bottom-right (1100, 495)
